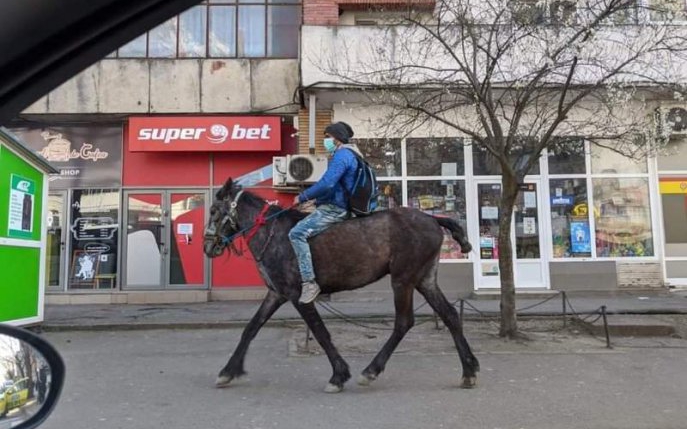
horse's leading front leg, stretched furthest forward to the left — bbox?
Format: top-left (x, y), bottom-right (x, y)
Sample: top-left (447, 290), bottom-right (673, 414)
top-left (215, 291), bottom-right (287, 387)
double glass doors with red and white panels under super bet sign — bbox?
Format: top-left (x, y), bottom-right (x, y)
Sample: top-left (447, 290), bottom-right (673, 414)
top-left (124, 190), bottom-right (208, 289)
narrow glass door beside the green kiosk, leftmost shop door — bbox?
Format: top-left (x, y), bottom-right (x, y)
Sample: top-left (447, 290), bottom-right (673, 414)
top-left (45, 191), bottom-right (67, 291)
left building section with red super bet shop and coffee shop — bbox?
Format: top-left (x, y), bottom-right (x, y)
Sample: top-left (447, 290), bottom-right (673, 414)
top-left (12, 0), bottom-right (302, 303)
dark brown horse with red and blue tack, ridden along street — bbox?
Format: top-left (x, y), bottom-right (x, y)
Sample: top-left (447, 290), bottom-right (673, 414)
top-left (204, 178), bottom-right (479, 393)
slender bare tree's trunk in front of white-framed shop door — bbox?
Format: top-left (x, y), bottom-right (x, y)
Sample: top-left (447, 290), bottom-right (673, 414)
top-left (498, 174), bottom-right (518, 338)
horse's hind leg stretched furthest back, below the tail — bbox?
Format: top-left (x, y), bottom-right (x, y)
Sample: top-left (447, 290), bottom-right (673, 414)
top-left (417, 270), bottom-right (479, 388)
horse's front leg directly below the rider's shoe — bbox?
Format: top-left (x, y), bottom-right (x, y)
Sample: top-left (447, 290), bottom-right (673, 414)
top-left (293, 300), bottom-right (351, 393)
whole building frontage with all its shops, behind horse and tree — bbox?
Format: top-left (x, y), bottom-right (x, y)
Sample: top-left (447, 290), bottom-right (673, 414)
top-left (13, 0), bottom-right (687, 303)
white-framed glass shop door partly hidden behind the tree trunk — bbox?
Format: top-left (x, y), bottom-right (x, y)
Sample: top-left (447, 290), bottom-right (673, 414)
top-left (475, 180), bottom-right (548, 289)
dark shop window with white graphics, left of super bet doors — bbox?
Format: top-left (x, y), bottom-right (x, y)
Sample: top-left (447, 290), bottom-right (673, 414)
top-left (67, 189), bottom-right (119, 290)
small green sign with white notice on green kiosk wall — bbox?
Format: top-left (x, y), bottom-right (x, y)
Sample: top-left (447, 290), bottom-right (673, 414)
top-left (7, 174), bottom-right (36, 238)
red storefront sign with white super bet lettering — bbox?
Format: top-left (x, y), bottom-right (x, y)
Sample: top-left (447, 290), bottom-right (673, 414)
top-left (128, 116), bottom-right (281, 152)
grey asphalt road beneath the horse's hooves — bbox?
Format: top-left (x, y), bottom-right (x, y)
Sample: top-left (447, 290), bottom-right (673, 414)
top-left (36, 324), bottom-right (687, 429)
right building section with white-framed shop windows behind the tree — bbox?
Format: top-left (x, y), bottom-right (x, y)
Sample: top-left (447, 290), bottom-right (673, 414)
top-left (301, 0), bottom-right (687, 293)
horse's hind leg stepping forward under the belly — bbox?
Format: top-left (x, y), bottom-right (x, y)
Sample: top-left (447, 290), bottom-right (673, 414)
top-left (358, 279), bottom-right (415, 386)
